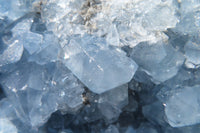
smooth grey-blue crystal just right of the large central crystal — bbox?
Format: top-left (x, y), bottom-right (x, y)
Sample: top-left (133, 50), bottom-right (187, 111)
top-left (131, 42), bottom-right (184, 82)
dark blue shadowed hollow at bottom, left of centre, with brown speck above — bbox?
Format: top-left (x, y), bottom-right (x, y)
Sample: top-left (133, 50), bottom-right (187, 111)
top-left (44, 87), bottom-right (107, 133)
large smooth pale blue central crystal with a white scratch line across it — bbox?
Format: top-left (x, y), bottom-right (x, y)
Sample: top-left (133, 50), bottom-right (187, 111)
top-left (62, 35), bottom-right (138, 93)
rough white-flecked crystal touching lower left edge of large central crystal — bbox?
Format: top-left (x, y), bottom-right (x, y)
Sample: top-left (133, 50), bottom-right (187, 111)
top-left (52, 63), bottom-right (84, 108)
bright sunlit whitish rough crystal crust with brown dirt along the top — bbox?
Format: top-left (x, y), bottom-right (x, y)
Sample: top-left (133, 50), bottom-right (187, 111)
top-left (42, 0), bottom-right (178, 47)
